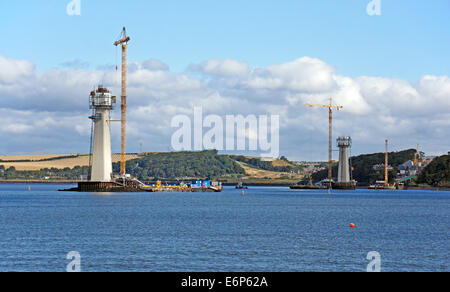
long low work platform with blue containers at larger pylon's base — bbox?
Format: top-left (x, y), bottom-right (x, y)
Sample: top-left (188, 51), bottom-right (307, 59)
top-left (62, 179), bottom-right (223, 193)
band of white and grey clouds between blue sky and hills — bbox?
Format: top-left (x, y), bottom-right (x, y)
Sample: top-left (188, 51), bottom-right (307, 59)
top-left (0, 56), bottom-right (450, 159)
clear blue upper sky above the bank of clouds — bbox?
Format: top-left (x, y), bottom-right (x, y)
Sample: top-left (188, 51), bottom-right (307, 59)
top-left (0, 0), bottom-right (450, 82)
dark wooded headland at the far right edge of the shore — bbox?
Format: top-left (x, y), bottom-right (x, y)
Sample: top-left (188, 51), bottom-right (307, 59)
top-left (417, 155), bottom-right (450, 186)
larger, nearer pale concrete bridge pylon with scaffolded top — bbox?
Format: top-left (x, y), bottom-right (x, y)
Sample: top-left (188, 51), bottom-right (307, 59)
top-left (89, 86), bottom-right (116, 182)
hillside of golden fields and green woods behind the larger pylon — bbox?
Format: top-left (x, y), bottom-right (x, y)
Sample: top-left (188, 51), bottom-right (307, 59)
top-left (0, 150), bottom-right (302, 181)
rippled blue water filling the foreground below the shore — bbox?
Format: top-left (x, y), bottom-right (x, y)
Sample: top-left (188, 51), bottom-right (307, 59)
top-left (0, 185), bottom-right (450, 272)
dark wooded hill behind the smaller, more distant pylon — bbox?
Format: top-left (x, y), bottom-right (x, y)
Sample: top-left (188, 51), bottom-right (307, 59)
top-left (313, 149), bottom-right (416, 185)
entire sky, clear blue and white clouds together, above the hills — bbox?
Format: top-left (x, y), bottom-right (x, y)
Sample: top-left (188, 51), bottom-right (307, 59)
top-left (0, 0), bottom-right (450, 160)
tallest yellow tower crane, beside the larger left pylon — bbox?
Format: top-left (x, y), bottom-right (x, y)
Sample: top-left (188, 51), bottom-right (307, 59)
top-left (114, 27), bottom-right (131, 177)
